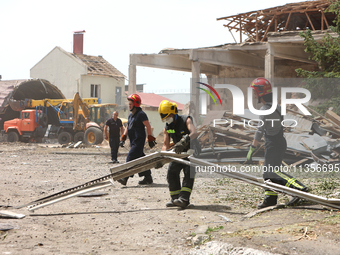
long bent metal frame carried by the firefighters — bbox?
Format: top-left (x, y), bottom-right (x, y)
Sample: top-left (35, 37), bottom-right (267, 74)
top-left (16, 151), bottom-right (340, 211)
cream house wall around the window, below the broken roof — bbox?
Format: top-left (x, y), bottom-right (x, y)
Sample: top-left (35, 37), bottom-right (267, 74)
top-left (80, 75), bottom-right (125, 104)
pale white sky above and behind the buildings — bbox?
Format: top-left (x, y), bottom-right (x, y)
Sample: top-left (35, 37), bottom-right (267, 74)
top-left (0, 0), bottom-right (300, 91)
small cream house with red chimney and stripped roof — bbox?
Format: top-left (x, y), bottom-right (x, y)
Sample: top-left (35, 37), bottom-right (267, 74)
top-left (30, 31), bottom-right (125, 105)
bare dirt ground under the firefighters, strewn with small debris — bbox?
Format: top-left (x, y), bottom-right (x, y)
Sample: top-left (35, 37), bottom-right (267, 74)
top-left (0, 142), bottom-right (340, 255)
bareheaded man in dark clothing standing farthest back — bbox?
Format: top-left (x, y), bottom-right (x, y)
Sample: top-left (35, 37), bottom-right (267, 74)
top-left (104, 111), bottom-right (124, 163)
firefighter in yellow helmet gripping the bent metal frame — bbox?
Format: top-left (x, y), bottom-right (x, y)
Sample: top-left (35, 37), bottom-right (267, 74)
top-left (155, 100), bottom-right (198, 208)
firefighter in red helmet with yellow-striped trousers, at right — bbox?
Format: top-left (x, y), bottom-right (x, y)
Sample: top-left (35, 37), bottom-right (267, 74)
top-left (247, 78), bottom-right (307, 209)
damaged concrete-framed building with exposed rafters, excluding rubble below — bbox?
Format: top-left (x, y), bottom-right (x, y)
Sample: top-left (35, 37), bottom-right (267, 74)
top-left (129, 0), bottom-right (335, 119)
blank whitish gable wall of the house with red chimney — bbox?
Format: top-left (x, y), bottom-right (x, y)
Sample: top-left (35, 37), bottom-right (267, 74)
top-left (30, 47), bottom-right (87, 98)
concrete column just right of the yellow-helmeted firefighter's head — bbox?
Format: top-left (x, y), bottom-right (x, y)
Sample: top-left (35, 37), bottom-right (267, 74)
top-left (190, 60), bottom-right (201, 125)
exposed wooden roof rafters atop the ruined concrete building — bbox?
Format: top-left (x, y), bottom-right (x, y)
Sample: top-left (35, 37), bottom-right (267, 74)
top-left (217, 0), bottom-right (336, 42)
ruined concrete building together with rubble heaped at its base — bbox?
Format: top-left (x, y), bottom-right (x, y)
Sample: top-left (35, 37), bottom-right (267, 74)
top-left (125, 0), bottom-right (340, 165)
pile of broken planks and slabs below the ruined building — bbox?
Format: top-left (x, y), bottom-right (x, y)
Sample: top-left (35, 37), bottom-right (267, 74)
top-left (198, 106), bottom-right (340, 166)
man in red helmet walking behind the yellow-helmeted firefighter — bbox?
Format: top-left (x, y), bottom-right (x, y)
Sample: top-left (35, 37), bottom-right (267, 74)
top-left (118, 94), bottom-right (156, 185)
